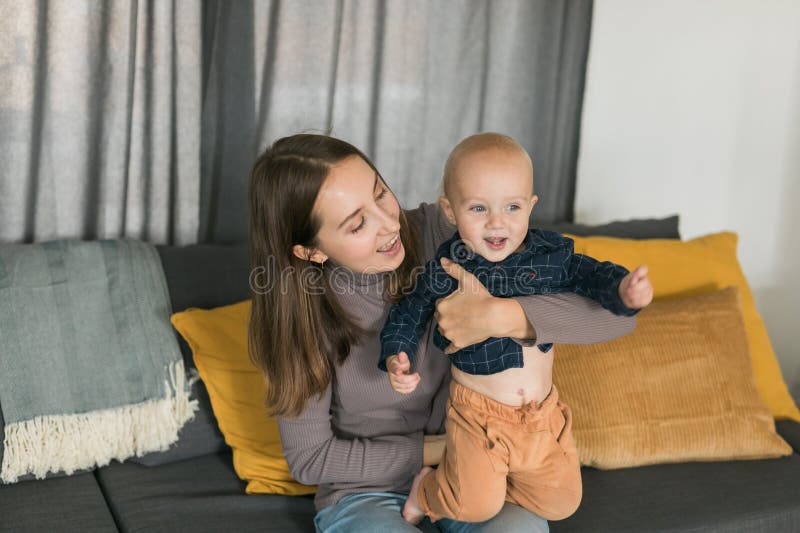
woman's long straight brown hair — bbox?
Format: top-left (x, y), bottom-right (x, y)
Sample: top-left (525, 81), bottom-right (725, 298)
top-left (248, 134), bottom-right (420, 416)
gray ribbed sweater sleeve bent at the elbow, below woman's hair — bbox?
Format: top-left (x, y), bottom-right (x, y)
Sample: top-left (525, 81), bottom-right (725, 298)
top-left (278, 385), bottom-right (423, 485)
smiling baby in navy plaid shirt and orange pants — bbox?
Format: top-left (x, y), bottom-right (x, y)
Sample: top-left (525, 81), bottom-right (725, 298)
top-left (379, 133), bottom-right (653, 523)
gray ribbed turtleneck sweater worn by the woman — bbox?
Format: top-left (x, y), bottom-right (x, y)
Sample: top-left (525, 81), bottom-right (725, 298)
top-left (278, 204), bottom-right (636, 509)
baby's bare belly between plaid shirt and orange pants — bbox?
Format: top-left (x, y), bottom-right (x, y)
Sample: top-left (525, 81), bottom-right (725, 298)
top-left (451, 346), bottom-right (555, 406)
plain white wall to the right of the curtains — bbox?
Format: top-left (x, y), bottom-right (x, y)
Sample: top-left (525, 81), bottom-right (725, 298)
top-left (576, 0), bottom-right (800, 397)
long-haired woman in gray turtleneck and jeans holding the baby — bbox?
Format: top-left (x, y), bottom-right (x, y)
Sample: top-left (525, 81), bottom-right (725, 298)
top-left (249, 135), bottom-right (634, 532)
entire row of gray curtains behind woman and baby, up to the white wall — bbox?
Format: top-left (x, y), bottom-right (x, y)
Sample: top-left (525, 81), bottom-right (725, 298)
top-left (0, 0), bottom-right (592, 244)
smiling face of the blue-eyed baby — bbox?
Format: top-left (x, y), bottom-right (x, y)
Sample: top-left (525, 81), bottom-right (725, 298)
top-left (440, 148), bottom-right (537, 262)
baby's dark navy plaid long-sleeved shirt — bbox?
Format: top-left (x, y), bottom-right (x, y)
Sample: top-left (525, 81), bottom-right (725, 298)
top-left (378, 229), bottom-right (639, 375)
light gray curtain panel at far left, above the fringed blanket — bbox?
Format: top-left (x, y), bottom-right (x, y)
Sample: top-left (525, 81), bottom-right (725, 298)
top-left (0, 0), bottom-right (202, 244)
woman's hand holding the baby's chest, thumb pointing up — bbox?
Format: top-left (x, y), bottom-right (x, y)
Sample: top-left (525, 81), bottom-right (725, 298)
top-left (434, 258), bottom-right (536, 354)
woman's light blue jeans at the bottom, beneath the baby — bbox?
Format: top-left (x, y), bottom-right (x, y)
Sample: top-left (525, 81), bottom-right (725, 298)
top-left (314, 492), bottom-right (549, 533)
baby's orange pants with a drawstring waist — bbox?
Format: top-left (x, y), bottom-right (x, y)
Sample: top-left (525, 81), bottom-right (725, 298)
top-left (418, 381), bottom-right (583, 522)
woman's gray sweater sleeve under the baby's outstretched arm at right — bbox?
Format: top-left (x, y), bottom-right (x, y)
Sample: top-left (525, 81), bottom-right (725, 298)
top-left (514, 292), bottom-right (636, 346)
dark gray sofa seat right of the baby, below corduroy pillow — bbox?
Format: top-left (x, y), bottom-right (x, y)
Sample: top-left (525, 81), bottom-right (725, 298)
top-left (550, 454), bottom-right (800, 533)
